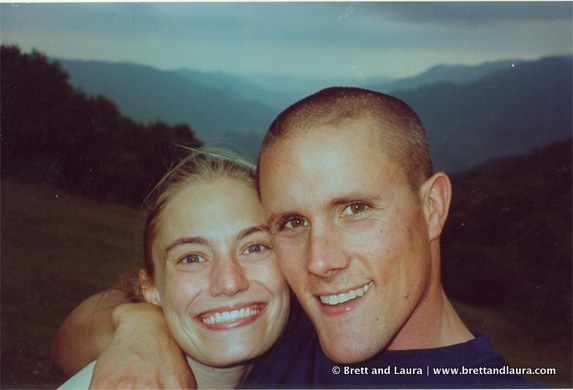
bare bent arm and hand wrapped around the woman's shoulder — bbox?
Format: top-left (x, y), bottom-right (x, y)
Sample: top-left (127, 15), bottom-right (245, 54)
top-left (52, 290), bottom-right (196, 389)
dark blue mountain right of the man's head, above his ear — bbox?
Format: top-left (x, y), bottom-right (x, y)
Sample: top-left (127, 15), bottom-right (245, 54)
top-left (395, 57), bottom-right (573, 172)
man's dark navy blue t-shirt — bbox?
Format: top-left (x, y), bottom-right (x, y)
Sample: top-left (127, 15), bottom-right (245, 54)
top-left (242, 304), bottom-right (538, 388)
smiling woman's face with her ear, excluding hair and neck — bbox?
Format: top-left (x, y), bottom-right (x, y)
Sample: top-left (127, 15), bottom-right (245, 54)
top-left (144, 178), bottom-right (290, 367)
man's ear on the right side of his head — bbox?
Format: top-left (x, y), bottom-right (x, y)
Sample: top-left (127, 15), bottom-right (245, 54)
top-left (421, 172), bottom-right (452, 240)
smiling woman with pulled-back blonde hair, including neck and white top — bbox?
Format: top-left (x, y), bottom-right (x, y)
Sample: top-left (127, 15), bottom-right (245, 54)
top-left (58, 151), bottom-right (290, 388)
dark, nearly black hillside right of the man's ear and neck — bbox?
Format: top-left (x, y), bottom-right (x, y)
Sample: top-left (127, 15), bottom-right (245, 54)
top-left (442, 138), bottom-right (573, 332)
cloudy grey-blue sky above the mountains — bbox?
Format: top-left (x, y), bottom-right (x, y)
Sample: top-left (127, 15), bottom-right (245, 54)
top-left (0, 1), bottom-right (573, 78)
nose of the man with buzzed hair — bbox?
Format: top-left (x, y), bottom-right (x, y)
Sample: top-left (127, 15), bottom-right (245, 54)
top-left (308, 229), bottom-right (350, 278)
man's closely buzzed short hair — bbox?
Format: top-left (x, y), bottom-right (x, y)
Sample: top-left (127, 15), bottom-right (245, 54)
top-left (259, 87), bottom-right (433, 190)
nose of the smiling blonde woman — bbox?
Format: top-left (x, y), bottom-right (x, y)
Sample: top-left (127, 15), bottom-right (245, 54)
top-left (209, 257), bottom-right (249, 296)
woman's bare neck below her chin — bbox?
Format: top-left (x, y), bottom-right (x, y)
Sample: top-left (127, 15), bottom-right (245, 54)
top-left (187, 356), bottom-right (250, 389)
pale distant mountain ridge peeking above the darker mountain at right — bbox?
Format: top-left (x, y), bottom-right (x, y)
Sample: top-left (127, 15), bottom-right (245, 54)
top-left (368, 60), bottom-right (523, 94)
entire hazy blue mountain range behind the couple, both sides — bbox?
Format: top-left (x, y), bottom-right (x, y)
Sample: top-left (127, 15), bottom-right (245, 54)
top-left (55, 56), bottom-right (572, 172)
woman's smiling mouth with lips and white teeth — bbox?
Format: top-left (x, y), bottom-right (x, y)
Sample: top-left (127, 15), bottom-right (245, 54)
top-left (197, 302), bottom-right (266, 328)
